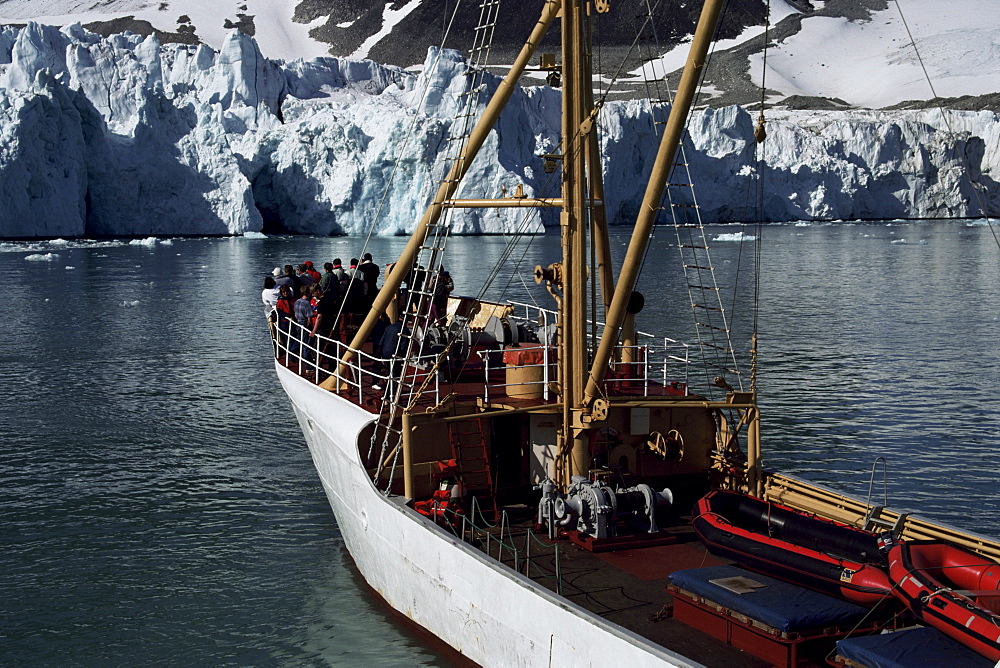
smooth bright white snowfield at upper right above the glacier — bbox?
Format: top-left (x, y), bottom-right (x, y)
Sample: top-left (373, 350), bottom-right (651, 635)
top-left (749, 0), bottom-right (1000, 108)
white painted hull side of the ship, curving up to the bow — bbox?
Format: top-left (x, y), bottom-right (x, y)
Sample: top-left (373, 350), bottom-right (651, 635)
top-left (275, 364), bottom-right (699, 666)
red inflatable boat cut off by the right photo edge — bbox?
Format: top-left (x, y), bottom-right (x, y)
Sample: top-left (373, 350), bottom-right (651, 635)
top-left (889, 541), bottom-right (1000, 661)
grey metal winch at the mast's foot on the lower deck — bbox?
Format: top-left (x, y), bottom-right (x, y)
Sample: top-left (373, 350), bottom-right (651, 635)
top-left (538, 476), bottom-right (674, 540)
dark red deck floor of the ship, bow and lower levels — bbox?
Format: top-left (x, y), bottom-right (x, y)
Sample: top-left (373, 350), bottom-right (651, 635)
top-left (279, 328), bottom-right (868, 668)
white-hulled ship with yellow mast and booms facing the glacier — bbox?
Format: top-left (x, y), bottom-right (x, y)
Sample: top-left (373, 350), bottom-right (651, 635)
top-left (271, 0), bottom-right (1000, 666)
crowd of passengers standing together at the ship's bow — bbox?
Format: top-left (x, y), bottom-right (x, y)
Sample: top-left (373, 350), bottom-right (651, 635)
top-left (261, 253), bottom-right (454, 366)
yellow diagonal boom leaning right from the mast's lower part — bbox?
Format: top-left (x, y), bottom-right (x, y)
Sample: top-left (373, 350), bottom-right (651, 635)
top-left (584, 0), bottom-right (723, 407)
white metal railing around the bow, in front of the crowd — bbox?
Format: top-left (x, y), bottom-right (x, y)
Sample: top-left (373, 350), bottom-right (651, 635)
top-left (271, 318), bottom-right (441, 404)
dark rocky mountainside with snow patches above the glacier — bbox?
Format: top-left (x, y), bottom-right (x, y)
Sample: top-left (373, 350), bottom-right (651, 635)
top-left (0, 0), bottom-right (1000, 109)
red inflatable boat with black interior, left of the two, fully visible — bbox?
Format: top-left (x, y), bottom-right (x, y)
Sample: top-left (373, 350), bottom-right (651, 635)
top-left (692, 490), bottom-right (892, 606)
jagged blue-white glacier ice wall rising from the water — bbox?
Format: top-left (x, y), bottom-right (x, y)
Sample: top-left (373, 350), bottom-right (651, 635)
top-left (0, 23), bottom-right (1000, 238)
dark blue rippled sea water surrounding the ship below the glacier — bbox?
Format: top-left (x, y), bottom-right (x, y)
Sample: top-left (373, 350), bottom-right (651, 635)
top-left (0, 221), bottom-right (1000, 665)
